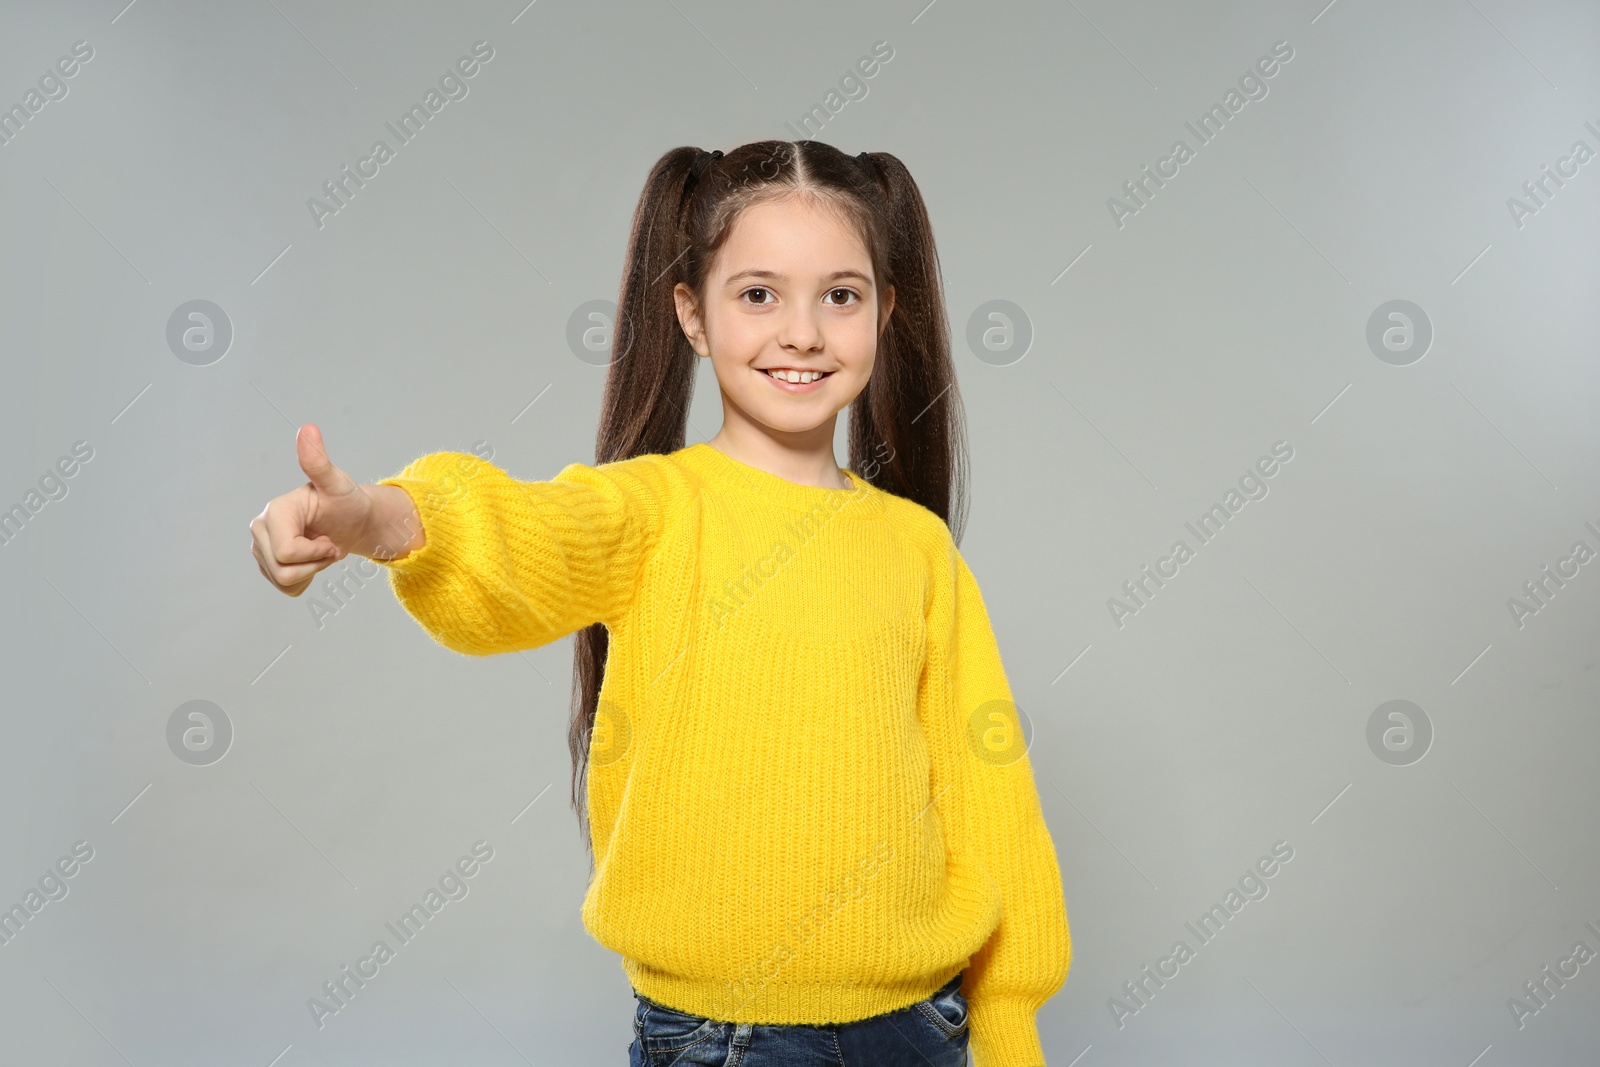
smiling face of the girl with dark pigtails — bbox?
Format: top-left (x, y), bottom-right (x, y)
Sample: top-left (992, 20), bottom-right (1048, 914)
top-left (674, 197), bottom-right (894, 442)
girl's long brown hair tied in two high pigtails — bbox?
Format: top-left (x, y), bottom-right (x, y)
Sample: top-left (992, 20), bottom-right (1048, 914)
top-left (566, 141), bottom-right (966, 870)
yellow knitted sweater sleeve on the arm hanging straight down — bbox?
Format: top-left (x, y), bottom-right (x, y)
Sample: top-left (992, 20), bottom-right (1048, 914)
top-left (930, 542), bottom-right (1072, 1067)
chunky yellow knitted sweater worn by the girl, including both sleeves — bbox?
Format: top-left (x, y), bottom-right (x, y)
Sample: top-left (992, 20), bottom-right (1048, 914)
top-left (372, 443), bottom-right (1070, 1067)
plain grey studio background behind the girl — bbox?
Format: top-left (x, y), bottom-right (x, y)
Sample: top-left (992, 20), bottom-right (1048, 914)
top-left (0, 0), bottom-right (1600, 1067)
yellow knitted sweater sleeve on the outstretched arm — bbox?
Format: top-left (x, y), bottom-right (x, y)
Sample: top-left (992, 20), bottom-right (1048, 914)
top-left (374, 451), bottom-right (666, 656)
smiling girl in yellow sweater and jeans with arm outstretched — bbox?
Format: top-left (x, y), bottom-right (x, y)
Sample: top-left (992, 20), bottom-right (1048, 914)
top-left (251, 141), bottom-right (1070, 1067)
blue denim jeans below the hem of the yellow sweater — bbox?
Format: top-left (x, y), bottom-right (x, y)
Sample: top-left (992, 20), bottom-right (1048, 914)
top-left (627, 971), bottom-right (966, 1067)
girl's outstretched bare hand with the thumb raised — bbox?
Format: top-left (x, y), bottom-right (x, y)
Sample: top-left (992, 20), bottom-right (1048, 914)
top-left (250, 422), bottom-right (373, 597)
